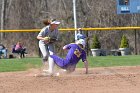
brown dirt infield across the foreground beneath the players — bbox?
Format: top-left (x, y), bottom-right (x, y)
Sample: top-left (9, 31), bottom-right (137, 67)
top-left (0, 66), bottom-right (140, 93)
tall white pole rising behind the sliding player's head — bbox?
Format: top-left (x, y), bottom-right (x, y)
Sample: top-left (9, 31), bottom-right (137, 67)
top-left (73, 0), bottom-right (77, 40)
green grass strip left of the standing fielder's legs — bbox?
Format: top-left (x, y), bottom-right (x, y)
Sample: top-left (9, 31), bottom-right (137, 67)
top-left (0, 58), bottom-right (42, 72)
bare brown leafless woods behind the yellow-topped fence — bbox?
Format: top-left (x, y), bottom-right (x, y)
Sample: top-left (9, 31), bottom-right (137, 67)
top-left (0, 0), bottom-right (140, 54)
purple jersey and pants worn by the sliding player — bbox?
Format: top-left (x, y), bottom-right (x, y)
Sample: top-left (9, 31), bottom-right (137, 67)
top-left (50, 44), bottom-right (86, 69)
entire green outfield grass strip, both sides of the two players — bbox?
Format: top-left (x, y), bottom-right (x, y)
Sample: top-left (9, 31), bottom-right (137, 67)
top-left (0, 55), bottom-right (140, 72)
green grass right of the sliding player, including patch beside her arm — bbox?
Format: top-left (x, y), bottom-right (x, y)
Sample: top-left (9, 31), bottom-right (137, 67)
top-left (77, 55), bottom-right (140, 67)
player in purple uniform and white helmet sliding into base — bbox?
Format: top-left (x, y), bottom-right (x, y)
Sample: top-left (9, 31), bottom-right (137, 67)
top-left (45, 39), bottom-right (88, 75)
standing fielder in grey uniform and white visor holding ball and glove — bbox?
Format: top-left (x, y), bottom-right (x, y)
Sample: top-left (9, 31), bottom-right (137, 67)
top-left (37, 20), bottom-right (60, 65)
